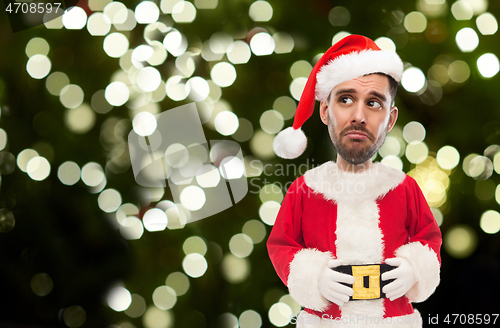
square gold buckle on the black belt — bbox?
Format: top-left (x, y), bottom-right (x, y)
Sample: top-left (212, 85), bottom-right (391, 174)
top-left (352, 264), bottom-right (380, 300)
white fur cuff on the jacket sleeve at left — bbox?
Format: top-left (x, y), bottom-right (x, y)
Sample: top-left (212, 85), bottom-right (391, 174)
top-left (288, 248), bottom-right (334, 312)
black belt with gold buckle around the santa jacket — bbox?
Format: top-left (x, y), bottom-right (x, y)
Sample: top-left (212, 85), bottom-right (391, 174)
top-left (333, 264), bottom-right (397, 301)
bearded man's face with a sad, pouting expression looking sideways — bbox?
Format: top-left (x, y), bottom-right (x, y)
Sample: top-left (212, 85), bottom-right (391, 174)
top-left (320, 74), bottom-right (398, 165)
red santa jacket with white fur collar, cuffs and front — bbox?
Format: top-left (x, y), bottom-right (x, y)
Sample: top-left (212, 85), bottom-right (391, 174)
top-left (267, 162), bottom-right (442, 328)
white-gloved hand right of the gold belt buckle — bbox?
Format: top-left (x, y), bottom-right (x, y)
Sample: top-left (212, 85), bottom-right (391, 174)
top-left (380, 257), bottom-right (415, 301)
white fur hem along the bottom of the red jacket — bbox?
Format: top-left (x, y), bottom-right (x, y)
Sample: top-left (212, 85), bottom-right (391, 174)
top-left (291, 310), bottom-right (422, 328)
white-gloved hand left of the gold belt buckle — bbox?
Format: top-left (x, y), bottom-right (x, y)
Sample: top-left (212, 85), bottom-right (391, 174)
top-left (318, 260), bottom-right (354, 306)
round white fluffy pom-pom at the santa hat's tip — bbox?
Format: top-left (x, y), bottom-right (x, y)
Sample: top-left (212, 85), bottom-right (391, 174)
top-left (273, 127), bottom-right (307, 159)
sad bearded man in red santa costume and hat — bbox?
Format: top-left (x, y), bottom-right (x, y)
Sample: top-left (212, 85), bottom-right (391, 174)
top-left (267, 35), bottom-right (442, 328)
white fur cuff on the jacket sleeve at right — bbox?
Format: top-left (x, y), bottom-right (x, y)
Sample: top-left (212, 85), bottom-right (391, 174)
top-left (395, 242), bottom-right (440, 302)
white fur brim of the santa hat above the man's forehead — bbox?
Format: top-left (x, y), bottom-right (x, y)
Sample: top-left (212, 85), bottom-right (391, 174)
top-left (316, 50), bottom-right (403, 101)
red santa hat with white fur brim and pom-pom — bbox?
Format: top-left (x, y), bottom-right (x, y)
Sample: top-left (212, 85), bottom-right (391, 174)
top-left (273, 35), bottom-right (403, 159)
